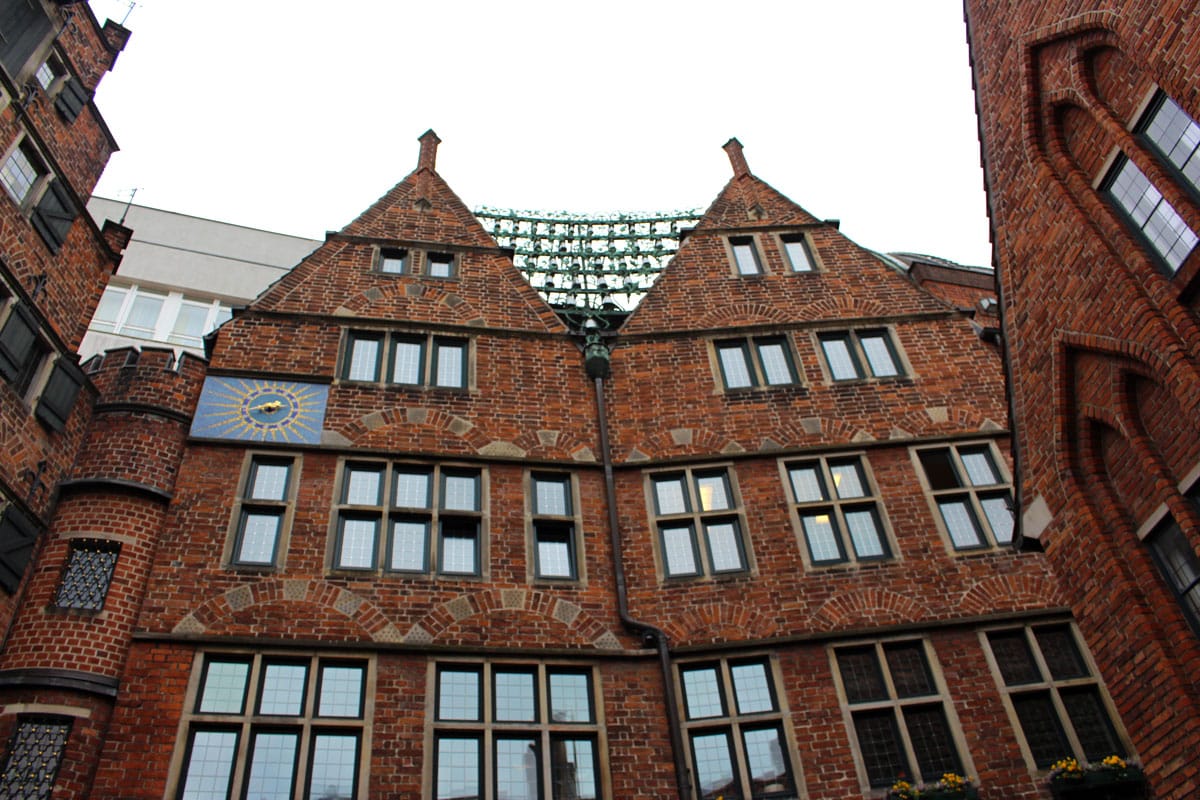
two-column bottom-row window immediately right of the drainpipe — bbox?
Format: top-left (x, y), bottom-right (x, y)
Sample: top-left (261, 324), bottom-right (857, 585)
top-left (679, 658), bottom-right (797, 800)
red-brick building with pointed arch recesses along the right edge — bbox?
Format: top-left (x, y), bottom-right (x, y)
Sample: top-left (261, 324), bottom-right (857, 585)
top-left (966, 0), bottom-right (1200, 798)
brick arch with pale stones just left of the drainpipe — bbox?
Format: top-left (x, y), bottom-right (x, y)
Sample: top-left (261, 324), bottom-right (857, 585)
top-left (404, 588), bottom-right (622, 649)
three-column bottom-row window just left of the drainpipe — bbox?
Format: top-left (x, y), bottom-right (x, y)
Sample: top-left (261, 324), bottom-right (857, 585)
top-left (432, 662), bottom-right (605, 800)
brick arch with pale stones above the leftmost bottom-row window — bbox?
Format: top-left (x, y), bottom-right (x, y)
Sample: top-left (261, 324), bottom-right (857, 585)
top-left (172, 578), bottom-right (400, 642)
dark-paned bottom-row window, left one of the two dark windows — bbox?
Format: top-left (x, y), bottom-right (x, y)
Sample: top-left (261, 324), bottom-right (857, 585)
top-left (834, 639), bottom-right (965, 787)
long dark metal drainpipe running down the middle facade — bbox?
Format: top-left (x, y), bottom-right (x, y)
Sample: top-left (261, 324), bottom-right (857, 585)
top-left (583, 327), bottom-right (691, 800)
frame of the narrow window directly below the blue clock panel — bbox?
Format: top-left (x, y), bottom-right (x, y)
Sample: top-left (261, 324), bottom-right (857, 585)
top-left (223, 450), bottom-right (304, 572)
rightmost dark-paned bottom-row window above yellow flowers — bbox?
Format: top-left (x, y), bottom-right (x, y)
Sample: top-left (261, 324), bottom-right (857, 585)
top-left (984, 622), bottom-right (1128, 769)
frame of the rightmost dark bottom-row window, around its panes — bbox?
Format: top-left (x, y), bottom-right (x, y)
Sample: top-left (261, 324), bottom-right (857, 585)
top-left (979, 619), bottom-right (1134, 776)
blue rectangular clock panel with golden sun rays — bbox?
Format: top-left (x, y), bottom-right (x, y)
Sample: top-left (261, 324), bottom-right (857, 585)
top-left (192, 377), bottom-right (329, 444)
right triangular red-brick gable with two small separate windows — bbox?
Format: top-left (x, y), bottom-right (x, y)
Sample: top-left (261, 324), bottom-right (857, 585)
top-left (622, 139), bottom-right (944, 335)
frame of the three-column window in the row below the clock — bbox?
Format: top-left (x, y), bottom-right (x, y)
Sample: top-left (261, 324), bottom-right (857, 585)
top-left (326, 457), bottom-right (490, 581)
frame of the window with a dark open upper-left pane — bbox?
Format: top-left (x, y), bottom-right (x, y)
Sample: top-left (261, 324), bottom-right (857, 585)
top-left (910, 439), bottom-right (1016, 554)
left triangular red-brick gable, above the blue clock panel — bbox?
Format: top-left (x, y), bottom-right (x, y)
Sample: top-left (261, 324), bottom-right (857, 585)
top-left (250, 131), bottom-right (564, 332)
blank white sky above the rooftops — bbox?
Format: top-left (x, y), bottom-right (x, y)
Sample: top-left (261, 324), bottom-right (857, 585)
top-left (82, 0), bottom-right (991, 265)
